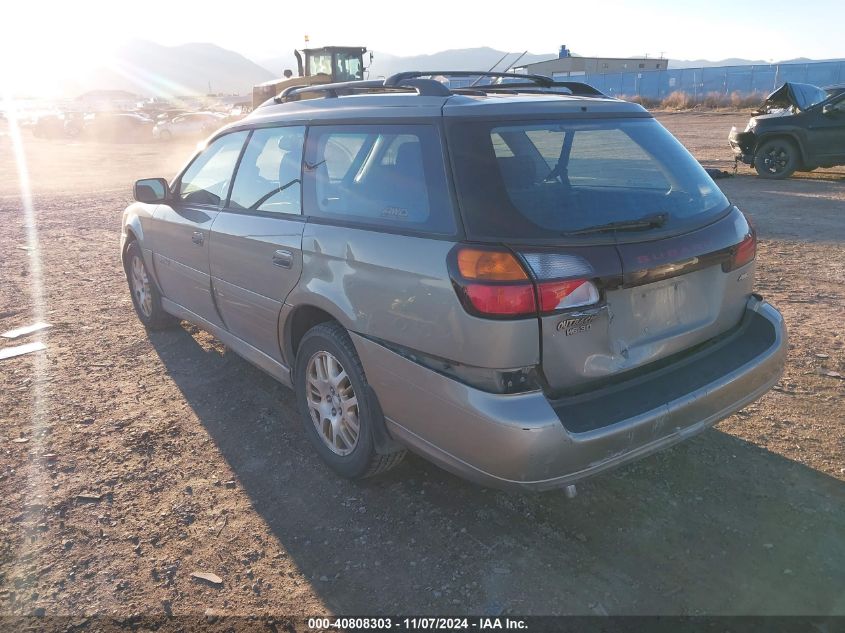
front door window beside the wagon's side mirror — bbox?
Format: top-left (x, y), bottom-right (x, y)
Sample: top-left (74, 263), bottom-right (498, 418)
top-left (177, 132), bottom-right (248, 206)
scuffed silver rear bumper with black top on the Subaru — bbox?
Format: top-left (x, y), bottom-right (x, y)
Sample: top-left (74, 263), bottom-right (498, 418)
top-left (353, 297), bottom-right (787, 490)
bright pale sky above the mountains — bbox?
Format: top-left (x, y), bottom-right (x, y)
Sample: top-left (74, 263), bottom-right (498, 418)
top-left (0, 0), bottom-right (845, 92)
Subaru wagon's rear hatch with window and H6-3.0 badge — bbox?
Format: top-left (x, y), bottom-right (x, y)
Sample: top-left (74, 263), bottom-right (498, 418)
top-left (447, 111), bottom-right (755, 396)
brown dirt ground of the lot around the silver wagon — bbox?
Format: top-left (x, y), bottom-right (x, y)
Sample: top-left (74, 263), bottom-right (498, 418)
top-left (0, 113), bottom-right (845, 625)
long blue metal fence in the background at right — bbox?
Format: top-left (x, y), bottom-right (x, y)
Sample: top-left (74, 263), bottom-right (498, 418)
top-left (568, 61), bottom-right (845, 99)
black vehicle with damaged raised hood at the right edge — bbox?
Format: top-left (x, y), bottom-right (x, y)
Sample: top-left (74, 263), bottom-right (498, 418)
top-left (728, 83), bottom-right (845, 179)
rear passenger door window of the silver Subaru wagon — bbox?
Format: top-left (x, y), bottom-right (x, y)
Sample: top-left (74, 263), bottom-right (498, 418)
top-left (229, 126), bottom-right (305, 215)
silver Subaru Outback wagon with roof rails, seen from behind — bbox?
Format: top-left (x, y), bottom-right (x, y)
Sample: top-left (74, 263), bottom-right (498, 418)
top-left (121, 73), bottom-right (786, 490)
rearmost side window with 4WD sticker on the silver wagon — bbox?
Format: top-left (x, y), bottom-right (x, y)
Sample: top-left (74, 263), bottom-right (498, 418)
top-left (304, 125), bottom-right (455, 235)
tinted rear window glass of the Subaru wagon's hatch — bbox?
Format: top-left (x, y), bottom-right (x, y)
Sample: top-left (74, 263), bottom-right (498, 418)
top-left (448, 119), bottom-right (728, 240)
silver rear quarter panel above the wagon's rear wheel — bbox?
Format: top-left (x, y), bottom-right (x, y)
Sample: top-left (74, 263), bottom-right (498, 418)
top-left (287, 222), bottom-right (539, 369)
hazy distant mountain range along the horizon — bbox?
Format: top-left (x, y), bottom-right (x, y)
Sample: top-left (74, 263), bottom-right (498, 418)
top-left (51, 40), bottom-right (836, 97)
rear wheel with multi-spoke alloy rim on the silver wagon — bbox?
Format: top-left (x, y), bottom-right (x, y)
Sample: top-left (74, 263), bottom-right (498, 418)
top-left (295, 322), bottom-right (405, 479)
